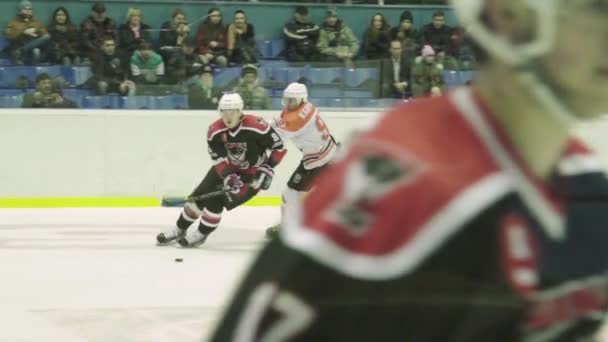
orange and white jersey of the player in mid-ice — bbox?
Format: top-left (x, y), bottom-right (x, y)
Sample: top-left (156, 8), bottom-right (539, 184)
top-left (275, 102), bottom-right (337, 170)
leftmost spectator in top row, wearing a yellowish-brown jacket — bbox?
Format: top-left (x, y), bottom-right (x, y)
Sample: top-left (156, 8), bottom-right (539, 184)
top-left (4, 0), bottom-right (50, 64)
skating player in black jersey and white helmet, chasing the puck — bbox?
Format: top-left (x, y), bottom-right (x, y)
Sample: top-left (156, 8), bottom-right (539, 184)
top-left (156, 93), bottom-right (286, 247)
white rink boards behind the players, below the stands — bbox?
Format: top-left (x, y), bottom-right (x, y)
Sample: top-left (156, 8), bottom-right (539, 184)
top-left (0, 109), bottom-right (379, 198)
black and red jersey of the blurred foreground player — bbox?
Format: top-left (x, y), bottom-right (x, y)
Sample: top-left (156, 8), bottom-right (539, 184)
top-left (213, 88), bottom-right (608, 342)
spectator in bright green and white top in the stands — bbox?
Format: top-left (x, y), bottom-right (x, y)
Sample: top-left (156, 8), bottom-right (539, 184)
top-left (130, 41), bottom-right (165, 84)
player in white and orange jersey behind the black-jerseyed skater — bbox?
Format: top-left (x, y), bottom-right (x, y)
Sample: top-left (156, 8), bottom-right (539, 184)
top-left (266, 82), bottom-right (337, 238)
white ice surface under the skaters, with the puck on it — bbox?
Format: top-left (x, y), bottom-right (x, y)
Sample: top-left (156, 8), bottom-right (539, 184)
top-left (0, 207), bottom-right (280, 342)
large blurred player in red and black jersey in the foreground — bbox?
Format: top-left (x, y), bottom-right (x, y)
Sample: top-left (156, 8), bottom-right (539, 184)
top-left (211, 0), bottom-right (608, 342)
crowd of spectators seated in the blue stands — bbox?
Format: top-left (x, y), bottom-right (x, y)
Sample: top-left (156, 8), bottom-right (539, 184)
top-left (5, 0), bottom-right (474, 109)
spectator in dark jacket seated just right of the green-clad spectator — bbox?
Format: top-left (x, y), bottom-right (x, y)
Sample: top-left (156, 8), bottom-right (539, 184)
top-left (165, 38), bottom-right (204, 84)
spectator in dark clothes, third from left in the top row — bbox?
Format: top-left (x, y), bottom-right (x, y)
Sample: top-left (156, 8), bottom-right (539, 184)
top-left (80, 2), bottom-right (118, 64)
